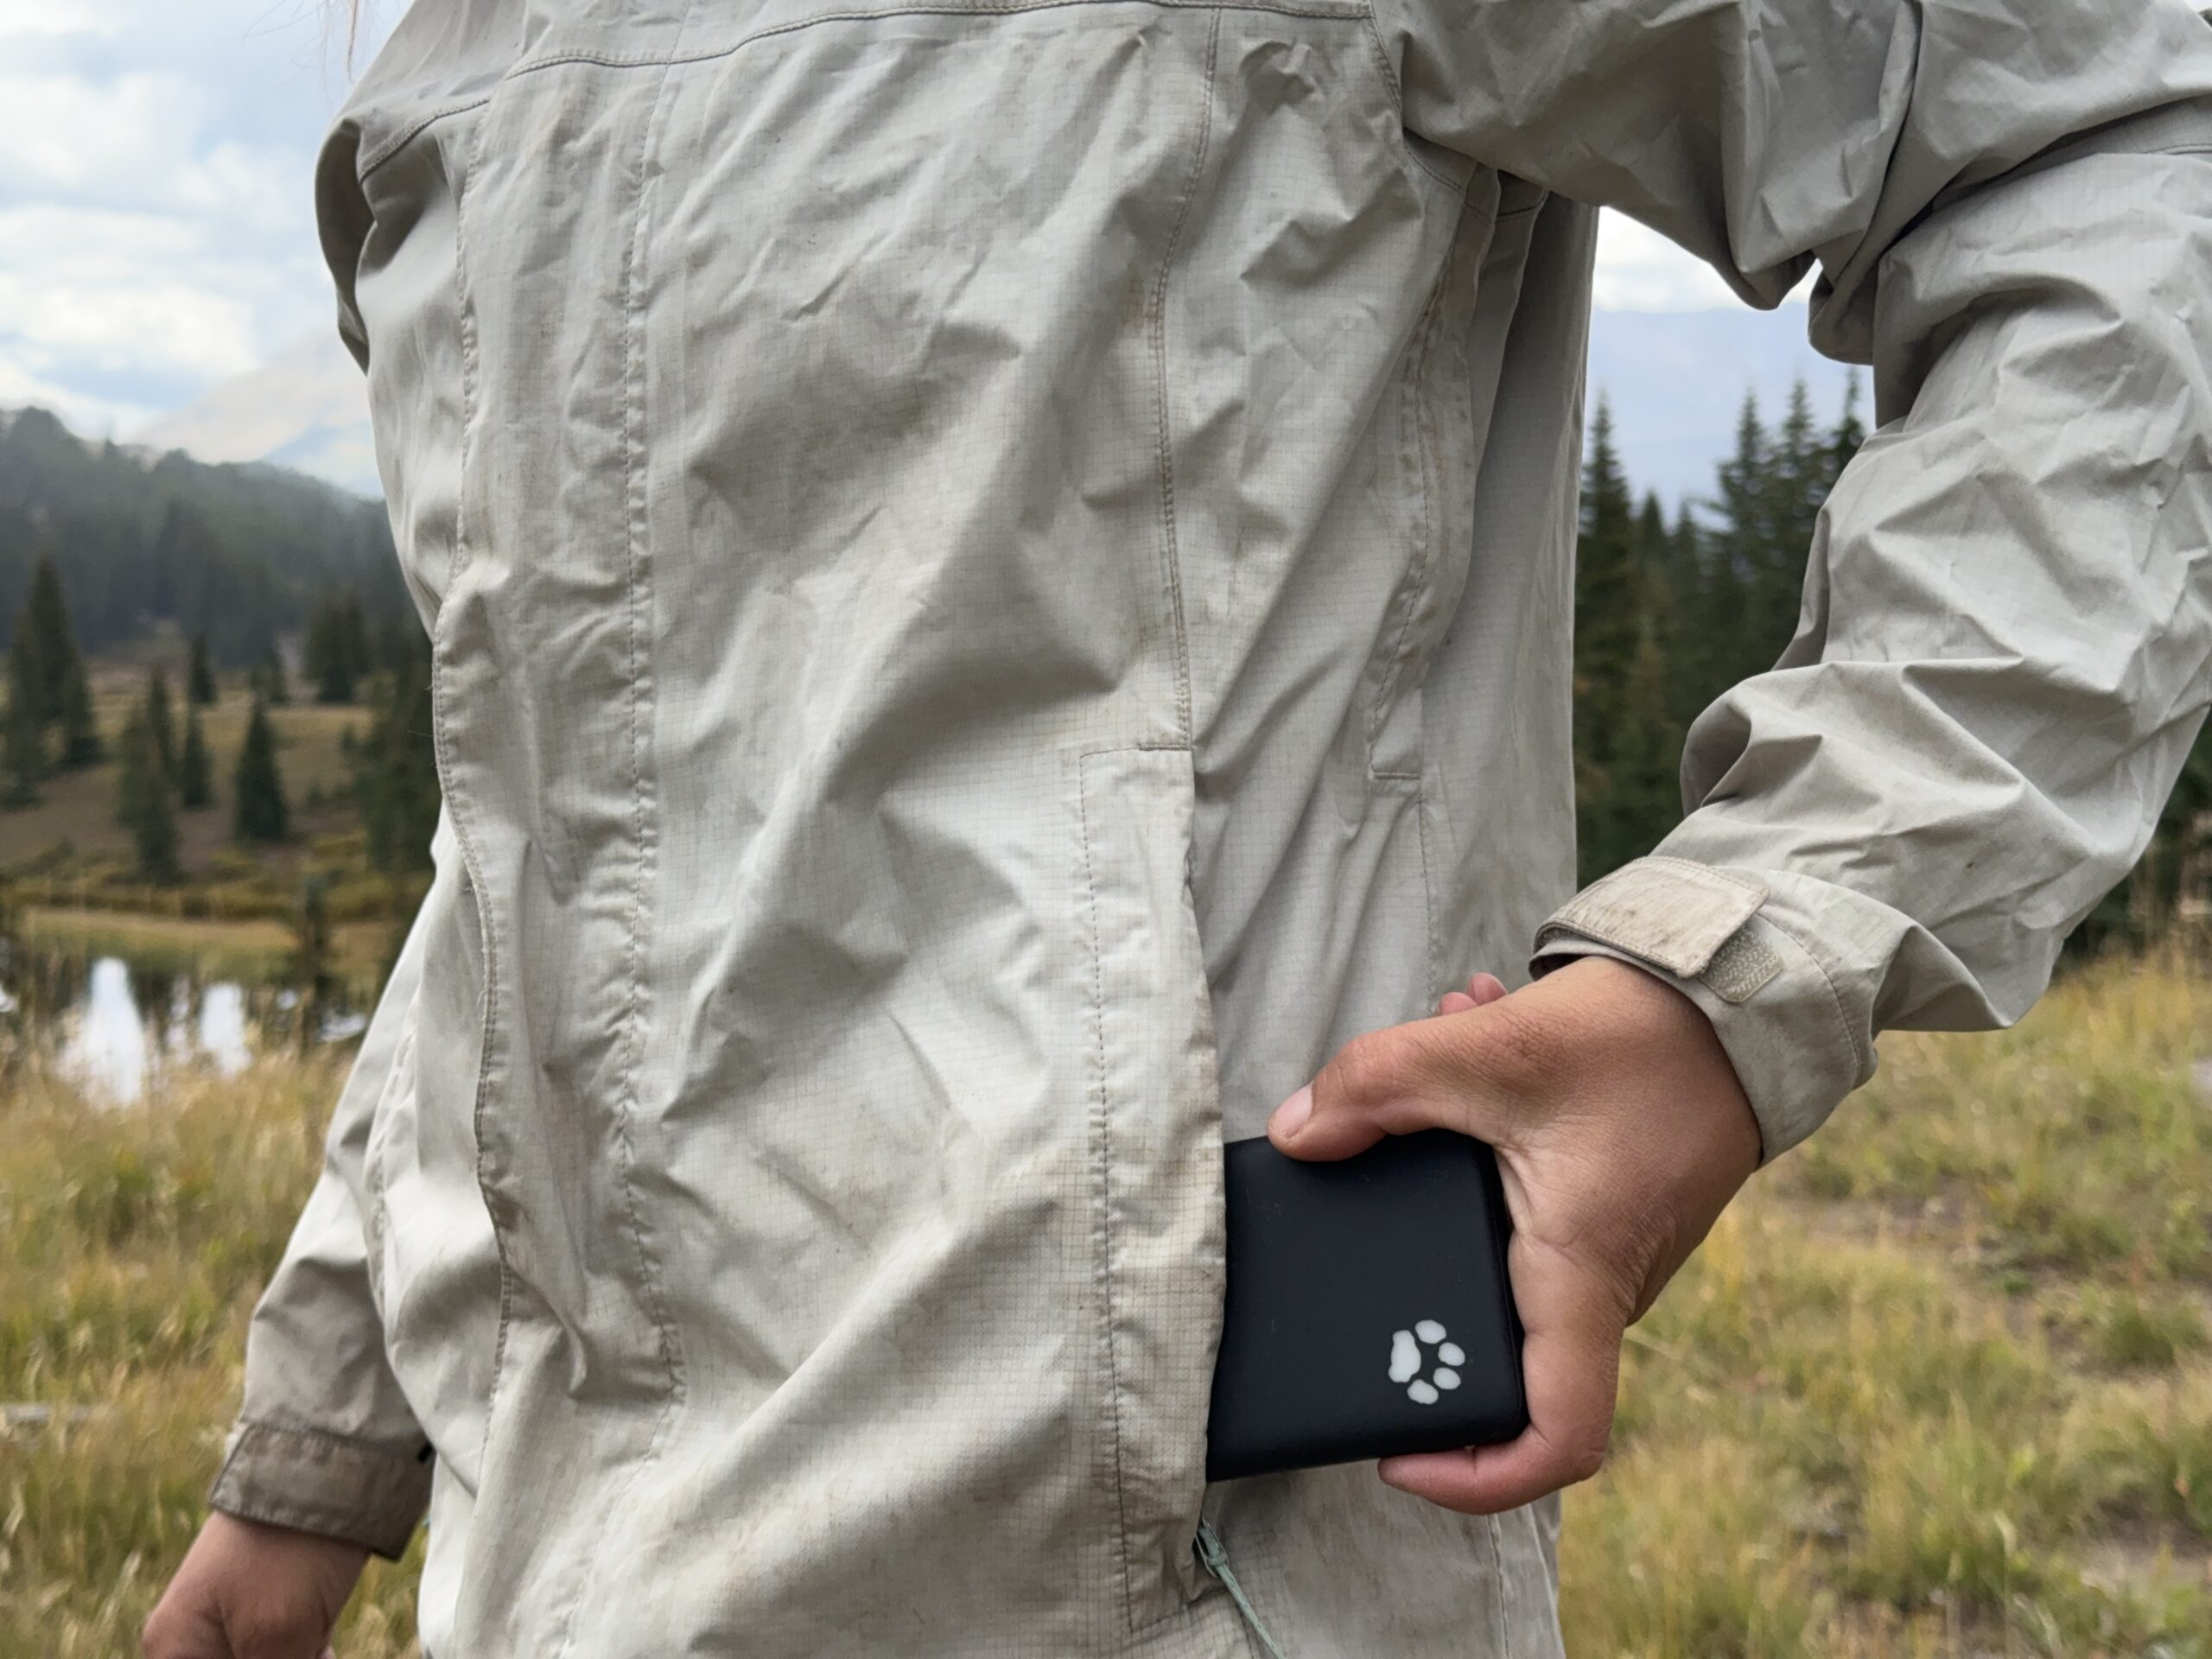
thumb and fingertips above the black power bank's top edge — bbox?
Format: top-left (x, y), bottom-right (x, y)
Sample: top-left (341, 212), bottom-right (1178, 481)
top-left (1268, 973), bottom-right (1526, 1159)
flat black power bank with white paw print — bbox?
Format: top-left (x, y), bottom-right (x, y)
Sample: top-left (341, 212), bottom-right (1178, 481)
top-left (1205, 1130), bottom-right (1529, 1480)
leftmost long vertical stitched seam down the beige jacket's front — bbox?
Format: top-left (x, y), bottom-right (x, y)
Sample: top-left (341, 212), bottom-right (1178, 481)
top-left (429, 84), bottom-right (515, 1458)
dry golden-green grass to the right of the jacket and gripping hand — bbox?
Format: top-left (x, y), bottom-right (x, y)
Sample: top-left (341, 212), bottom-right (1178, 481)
top-left (1561, 960), bottom-right (2212, 1659)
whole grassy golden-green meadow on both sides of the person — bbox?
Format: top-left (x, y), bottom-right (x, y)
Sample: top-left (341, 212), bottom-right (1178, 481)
top-left (0, 946), bottom-right (2212, 1659)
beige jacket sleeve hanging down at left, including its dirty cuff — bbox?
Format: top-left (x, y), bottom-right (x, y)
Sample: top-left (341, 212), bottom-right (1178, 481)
top-left (208, 810), bottom-right (449, 1557)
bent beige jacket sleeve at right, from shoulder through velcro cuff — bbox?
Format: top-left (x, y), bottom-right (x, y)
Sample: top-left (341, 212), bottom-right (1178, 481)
top-left (1378, 0), bottom-right (2212, 1157)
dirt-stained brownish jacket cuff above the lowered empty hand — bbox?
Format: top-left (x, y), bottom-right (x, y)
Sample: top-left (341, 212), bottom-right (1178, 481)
top-left (208, 1422), bottom-right (431, 1561)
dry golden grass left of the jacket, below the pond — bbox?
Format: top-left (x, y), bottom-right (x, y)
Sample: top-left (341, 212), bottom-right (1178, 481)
top-left (0, 1055), bottom-right (414, 1659)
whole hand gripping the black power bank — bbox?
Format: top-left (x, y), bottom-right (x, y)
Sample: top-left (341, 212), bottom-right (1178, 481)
top-left (1268, 956), bottom-right (1761, 1516)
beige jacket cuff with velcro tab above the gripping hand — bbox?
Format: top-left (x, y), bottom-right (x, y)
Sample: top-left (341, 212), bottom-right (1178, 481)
top-left (1529, 856), bottom-right (1873, 1164)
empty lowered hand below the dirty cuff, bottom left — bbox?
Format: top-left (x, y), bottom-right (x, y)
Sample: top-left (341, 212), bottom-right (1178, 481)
top-left (139, 1510), bottom-right (370, 1659)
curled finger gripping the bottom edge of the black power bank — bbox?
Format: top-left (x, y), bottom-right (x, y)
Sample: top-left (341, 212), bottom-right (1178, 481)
top-left (1376, 1236), bottom-right (1628, 1516)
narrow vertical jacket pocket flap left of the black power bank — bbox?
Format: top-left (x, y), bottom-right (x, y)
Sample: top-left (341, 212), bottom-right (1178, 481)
top-left (1079, 747), bottom-right (1224, 1630)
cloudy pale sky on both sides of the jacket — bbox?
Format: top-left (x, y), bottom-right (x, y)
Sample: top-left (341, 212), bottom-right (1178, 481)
top-left (0, 0), bottom-right (1760, 448)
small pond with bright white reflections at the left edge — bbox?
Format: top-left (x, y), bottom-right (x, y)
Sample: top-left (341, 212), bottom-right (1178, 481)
top-left (0, 923), bottom-right (374, 1106)
